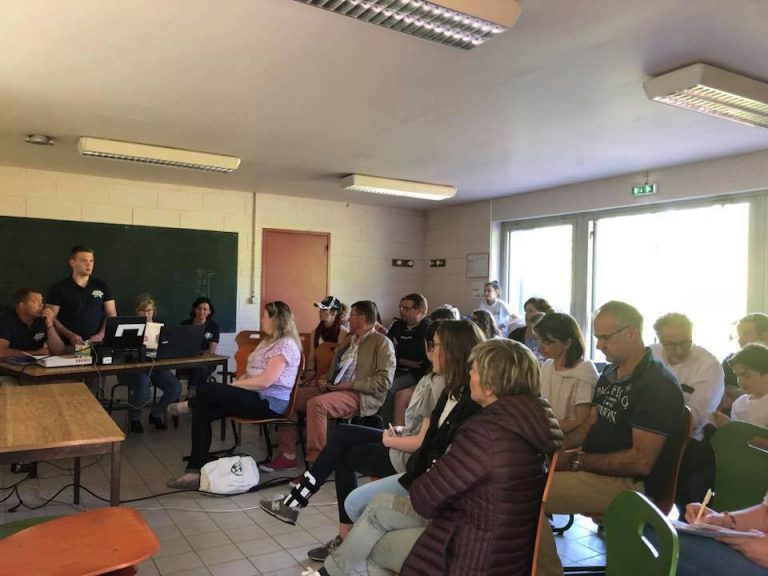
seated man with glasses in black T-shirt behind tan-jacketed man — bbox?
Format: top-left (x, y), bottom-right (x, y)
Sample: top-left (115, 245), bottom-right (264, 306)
top-left (381, 293), bottom-right (430, 426)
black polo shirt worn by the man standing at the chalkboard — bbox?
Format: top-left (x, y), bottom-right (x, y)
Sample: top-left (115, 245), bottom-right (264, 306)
top-left (45, 276), bottom-right (114, 340)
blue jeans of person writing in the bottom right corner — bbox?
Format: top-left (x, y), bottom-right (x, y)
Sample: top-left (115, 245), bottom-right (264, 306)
top-left (677, 534), bottom-right (768, 576)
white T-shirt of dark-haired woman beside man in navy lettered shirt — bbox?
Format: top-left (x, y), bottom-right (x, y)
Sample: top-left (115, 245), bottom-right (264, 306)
top-left (541, 359), bottom-right (599, 420)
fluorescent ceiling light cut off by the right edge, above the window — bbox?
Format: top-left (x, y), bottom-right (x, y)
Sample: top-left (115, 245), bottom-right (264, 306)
top-left (643, 64), bottom-right (768, 128)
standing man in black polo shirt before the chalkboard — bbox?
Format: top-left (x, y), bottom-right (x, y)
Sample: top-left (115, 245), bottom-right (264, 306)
top-left (46, 246), bottom-right (117, 345)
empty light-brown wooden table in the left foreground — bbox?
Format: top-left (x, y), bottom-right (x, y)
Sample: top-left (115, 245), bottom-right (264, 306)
top-left (0, 382), bottom-right (125, 506)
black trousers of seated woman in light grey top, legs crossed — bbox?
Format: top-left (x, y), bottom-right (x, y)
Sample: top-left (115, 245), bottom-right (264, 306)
top-left (309, 424), bottom-right (397, 524)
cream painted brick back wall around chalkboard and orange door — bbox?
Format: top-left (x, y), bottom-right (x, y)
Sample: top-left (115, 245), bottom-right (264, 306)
top-left (0, 166), bottom-right (425, 355)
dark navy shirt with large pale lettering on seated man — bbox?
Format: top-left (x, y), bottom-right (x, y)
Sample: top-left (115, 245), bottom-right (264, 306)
top-left (584, 348), bottom-right (685, 496)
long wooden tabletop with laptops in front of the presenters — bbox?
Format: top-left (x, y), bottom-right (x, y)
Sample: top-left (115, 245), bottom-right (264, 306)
top-left (0, 353), bottom-right (229, 384)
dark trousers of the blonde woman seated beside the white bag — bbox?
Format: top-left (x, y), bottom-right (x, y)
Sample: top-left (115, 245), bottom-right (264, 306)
top-left (187, 382), bottom-right (281, 472)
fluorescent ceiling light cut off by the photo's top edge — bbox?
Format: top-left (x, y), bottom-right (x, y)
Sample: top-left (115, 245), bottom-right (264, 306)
top-left (296, 0), bottom-right (520, 50)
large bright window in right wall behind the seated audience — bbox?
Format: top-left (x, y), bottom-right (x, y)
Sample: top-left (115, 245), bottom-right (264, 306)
top-left (502, 197), bottom-right (752, 360)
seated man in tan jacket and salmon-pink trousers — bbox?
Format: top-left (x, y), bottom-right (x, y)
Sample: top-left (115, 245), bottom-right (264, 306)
top-left (259, 300), bottom-right (395, 472)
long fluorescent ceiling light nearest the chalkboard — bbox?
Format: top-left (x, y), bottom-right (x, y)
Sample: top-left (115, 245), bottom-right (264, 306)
top-left (77, 136), bottom-right (240, 173)
